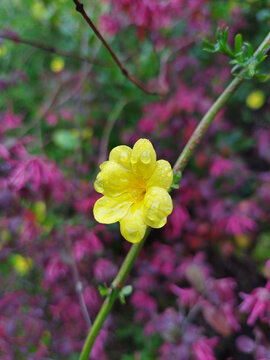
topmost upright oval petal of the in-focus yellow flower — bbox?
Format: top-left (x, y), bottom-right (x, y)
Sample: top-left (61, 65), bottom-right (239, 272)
top-left (130, 139), bottom-right (157, 179)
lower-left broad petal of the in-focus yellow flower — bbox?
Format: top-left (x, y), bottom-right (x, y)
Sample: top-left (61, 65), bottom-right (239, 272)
top-left (93, 193), bottom-right (133, 224)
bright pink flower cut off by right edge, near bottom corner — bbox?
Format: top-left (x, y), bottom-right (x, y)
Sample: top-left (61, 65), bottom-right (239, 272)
top-left (240, 280), bottom-right (270, 325)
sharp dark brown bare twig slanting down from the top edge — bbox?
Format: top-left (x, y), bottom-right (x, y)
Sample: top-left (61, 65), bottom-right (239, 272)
top-left (73, 0), bottom-right (165, 96)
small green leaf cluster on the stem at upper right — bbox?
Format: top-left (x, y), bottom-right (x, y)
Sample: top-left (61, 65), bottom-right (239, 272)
top-left (203, 27), bottom-right (269, 81)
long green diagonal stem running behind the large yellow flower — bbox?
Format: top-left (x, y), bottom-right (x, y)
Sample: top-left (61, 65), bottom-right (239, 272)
top-left (79, 32), bottom-right (270, 360)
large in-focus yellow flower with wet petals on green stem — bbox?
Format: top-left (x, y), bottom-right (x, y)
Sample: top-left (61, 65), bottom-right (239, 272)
top-left (94, 139), bottom-right (173, 243)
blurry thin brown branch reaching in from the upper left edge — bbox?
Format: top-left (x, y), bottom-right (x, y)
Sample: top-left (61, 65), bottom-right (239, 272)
top-left (0, 30), bottom-right (102, 65)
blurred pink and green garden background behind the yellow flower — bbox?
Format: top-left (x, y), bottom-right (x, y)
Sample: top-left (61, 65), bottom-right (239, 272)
top-left (0, 0), bottom-right (270, 360)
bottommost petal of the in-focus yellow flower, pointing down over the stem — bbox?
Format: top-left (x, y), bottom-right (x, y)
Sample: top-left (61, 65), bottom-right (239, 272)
top-left (120, 203), bottom-right (146, 243)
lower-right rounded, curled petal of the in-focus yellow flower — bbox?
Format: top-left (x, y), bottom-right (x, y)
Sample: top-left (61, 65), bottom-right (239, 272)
top-left (143, 186), bottom-right (173, 229)
